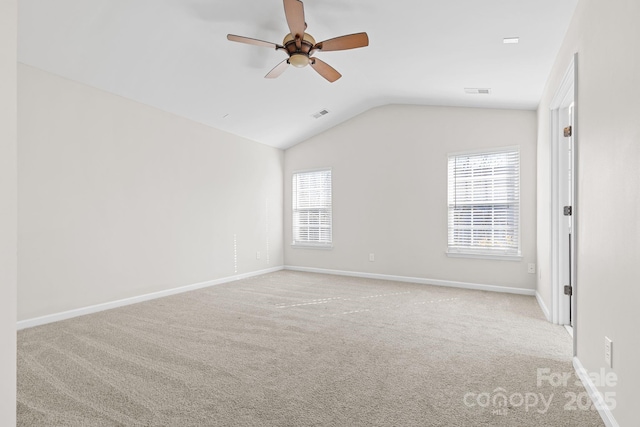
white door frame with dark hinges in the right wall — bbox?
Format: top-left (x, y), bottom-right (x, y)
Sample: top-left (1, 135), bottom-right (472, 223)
top-left (549, 53), bottom-right (579, 353)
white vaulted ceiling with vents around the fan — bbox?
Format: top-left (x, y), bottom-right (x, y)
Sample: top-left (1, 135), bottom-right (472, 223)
top-left (18, 0), bottom-right (578, 148)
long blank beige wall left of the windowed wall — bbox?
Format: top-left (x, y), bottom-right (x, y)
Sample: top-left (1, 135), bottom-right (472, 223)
top-left (18, 65), bottom-right (283, 320)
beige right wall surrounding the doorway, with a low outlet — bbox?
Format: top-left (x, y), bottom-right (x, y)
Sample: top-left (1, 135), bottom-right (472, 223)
top-left (538, 0), bottom-right (640, 426)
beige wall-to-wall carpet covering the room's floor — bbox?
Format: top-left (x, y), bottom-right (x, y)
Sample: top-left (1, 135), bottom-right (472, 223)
top-left (17, 271), bottom-right (603, 427)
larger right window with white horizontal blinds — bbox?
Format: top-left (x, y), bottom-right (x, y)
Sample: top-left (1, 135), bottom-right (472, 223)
top-left (448, 147), bottom-right (520, 257)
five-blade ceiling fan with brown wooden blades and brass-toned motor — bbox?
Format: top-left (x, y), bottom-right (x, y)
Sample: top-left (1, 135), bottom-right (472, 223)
top-left (227, 0), bottom-right (369, 82)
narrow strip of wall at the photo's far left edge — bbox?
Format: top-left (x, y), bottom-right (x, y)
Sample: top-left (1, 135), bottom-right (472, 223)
top-left (0, 0), bottom-right (17, 426)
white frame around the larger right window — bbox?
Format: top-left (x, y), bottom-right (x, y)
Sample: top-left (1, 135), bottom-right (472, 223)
top-left (446, 145), bottom-right (522, 261)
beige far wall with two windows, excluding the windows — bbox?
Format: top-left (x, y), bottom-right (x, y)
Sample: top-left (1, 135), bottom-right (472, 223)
top-left (284, 105), bottom-right (536, 289)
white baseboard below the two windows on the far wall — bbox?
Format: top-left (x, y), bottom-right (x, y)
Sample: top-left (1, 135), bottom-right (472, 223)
top-left (284, 265), bottom-right (535, 296)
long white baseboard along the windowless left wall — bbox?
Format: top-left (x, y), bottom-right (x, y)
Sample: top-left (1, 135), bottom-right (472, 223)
top-left (16, 266), bottom-right (284, 330)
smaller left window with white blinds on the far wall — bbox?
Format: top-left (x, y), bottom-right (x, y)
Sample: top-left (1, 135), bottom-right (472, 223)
top-left (292, 169), bottom-right (332, 248)
